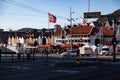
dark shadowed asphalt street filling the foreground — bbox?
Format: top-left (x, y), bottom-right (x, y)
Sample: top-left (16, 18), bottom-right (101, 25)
top-left (0, 54), bottom-right (120, 80)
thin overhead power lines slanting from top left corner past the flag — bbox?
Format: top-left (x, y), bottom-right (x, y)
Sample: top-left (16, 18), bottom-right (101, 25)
top-left (1, 0), bottom-right (67, 20)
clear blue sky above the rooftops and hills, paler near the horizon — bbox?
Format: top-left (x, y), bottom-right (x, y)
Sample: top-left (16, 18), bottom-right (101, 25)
top-left (0, 0), bottom-right (120, 30)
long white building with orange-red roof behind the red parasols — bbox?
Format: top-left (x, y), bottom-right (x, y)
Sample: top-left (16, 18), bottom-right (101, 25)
top-left (53, 25), bottom-right (94, 44)
